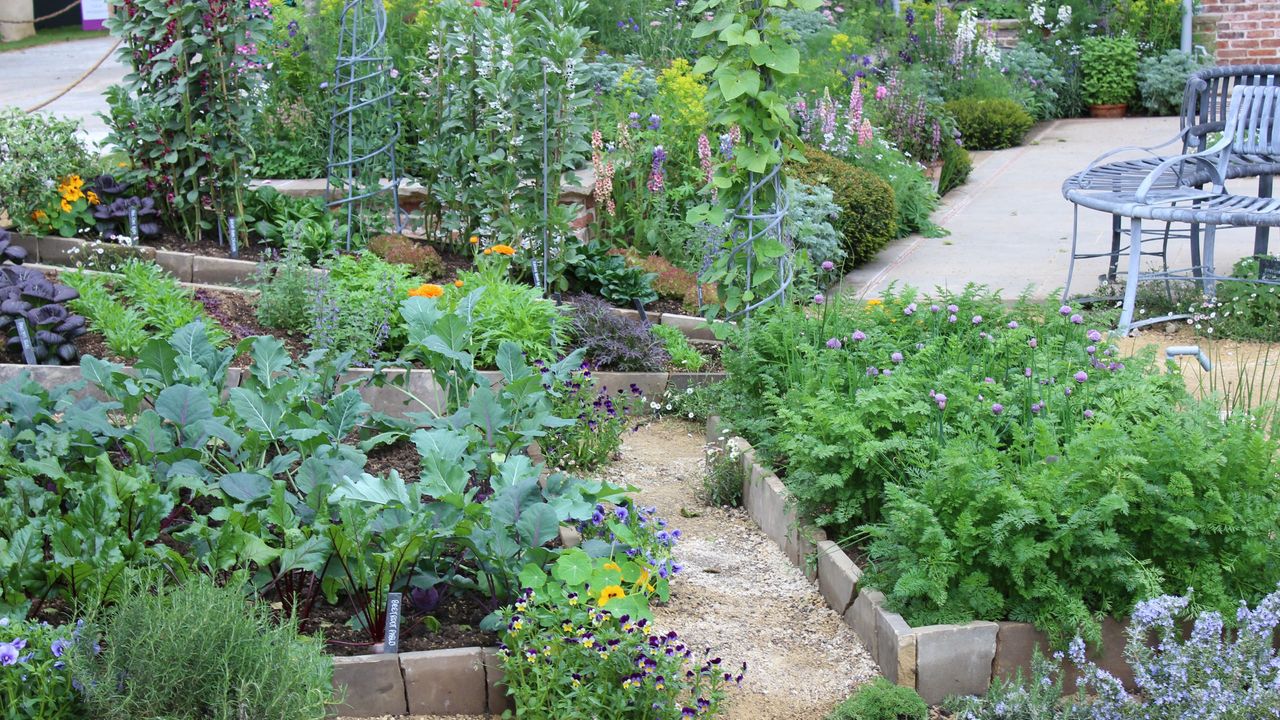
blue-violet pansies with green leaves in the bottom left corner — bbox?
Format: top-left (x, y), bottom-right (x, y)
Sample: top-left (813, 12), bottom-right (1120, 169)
top-left (0, 615), bottom-right (82, 720)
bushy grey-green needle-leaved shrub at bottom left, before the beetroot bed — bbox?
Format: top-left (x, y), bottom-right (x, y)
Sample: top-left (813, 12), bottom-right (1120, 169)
top-left (69, 575), bottom-right (333, 720)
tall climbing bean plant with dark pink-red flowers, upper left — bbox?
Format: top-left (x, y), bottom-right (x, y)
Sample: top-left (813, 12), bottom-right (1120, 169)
top-left (108, 0), bottom-right (271, 238)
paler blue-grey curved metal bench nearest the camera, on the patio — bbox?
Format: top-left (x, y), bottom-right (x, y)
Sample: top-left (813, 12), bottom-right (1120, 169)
top-left (1062, 83), bottom-right (1280, 331)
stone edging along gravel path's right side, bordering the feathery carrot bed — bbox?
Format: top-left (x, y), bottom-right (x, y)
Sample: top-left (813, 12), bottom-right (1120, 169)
top-left (707, 416), bottom-right (1133, 703)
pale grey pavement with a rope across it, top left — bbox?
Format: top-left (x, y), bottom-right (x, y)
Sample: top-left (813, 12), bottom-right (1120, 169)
top-left (0, 37), bottom-right (128, 145)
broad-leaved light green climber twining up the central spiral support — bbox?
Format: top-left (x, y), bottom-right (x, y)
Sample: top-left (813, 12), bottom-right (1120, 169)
top-left (689, 0), bottom-right (819, 315)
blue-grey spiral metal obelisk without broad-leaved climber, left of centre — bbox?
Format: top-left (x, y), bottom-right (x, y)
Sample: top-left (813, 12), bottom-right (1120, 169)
top-left (325, 0), bottom-right (404, 250)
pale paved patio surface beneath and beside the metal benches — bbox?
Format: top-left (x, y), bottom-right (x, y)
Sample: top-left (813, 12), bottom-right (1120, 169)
top-left (840, 117), bottom-right (1259, 299)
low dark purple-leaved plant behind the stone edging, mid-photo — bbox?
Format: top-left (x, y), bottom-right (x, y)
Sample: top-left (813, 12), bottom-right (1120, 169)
top-left (570, 295), bottom-right (671, 373)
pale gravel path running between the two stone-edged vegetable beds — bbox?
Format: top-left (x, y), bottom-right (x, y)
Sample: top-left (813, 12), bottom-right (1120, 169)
top-left (340, 420), bottom-right (878, 720)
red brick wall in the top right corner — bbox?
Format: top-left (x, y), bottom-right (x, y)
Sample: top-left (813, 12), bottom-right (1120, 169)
top-left (1196, 0), bottom-right (1280, 65)
